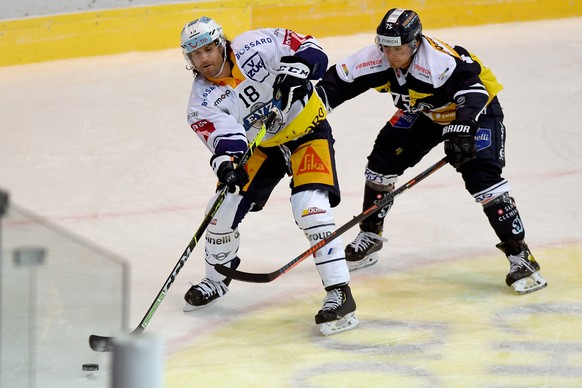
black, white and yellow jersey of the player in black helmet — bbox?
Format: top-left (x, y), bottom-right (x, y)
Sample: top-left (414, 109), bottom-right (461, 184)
top-left (317, 35), bottom-right (503, 125)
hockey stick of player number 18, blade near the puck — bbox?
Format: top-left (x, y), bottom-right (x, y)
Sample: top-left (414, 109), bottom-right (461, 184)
top-left (89, 111), bottom-right (276, 352)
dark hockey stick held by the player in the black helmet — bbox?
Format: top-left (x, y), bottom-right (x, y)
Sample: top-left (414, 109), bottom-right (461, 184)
top-left (214, 157), bottom-right (447, 283)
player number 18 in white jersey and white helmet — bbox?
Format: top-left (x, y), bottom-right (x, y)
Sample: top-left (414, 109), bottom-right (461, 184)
top-left (181, 17), bottom-right (358, 335)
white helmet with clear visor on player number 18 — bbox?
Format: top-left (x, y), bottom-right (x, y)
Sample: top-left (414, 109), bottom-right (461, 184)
top-left (180, 16), bottom-right (226, 65)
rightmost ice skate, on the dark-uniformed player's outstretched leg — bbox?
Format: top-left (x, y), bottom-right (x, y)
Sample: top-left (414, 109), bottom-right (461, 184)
top-left (497, 241), bottom-right (548, 294)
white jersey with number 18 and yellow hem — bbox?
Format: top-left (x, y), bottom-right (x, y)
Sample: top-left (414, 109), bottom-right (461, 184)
top-left (187, 28), bottom-right (327, 155)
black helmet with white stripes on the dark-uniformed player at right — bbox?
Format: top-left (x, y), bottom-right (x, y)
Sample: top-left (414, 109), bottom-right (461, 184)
top-left (376, 8), bottom-right (422, 46)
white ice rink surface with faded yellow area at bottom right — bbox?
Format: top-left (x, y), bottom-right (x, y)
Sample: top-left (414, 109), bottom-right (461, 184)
top-left (0, 19), bottom-right (582, 388)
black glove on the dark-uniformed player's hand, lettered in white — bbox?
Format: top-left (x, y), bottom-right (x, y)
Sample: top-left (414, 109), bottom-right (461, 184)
top-left (443, 119), bottom-right (479, 168)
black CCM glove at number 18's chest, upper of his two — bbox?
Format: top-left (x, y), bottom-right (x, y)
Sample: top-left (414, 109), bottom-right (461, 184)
top-left (273, 56), bottom-right (313, 112)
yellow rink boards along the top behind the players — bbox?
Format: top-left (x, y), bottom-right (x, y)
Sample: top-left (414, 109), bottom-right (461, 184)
top-left (0, 0), bottom-right (582, 66)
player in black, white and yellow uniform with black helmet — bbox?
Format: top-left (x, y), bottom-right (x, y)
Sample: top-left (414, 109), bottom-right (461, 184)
top-left (317, 8), bottom-right (547, 294)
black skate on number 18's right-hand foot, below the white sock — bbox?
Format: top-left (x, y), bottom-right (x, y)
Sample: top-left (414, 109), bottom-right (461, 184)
top-left (315, 285), bottom-right (359, 336)
